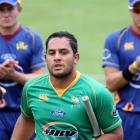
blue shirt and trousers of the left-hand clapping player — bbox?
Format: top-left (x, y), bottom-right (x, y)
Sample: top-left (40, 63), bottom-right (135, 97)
top-left (0, 26), bottom-right (46, 140)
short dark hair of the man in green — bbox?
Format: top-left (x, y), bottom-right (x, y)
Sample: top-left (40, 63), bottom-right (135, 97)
top-left (46, 31), bottom-right (78, 54)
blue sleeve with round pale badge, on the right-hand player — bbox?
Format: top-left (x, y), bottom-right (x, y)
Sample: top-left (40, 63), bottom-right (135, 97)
top-left (102, 32), bottom-right (120, 69)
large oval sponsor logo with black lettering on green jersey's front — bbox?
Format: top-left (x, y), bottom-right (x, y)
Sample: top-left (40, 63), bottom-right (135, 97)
top-left (42, 122), bottom-right (78, 140)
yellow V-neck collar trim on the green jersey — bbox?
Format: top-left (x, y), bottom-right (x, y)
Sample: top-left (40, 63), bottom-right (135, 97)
top-left (49, 71), bottom-right (81, 96)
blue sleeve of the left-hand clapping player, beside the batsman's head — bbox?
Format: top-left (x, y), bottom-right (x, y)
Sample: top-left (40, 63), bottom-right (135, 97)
top-left (31, 33), bottom-right (46, 70)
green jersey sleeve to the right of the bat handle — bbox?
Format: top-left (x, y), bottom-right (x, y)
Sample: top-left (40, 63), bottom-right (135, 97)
top-left (95, 86), bottom-right (122, 132)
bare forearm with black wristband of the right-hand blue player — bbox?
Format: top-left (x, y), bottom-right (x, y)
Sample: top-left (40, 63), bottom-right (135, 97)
top-left (104, 60), bottom-right (140, 91)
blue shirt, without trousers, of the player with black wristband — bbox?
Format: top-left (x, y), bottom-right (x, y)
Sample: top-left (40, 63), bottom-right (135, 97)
top-left (102, 27), bottom-right (140, 112)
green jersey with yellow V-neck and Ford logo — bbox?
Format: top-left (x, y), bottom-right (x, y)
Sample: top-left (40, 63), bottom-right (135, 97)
top-left (21, 72), bottom-right (121, 140)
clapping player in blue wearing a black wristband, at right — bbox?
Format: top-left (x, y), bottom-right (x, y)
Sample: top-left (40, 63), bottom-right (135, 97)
top-left (103, 0), bottom-right (140, 140)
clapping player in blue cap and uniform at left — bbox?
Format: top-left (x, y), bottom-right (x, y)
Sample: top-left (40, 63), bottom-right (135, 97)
top-left (0, 0), bottom-right (46, 140)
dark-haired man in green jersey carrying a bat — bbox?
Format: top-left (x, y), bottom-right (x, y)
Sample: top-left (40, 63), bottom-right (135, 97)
top-left (12, 32), bottom-right (123, 140)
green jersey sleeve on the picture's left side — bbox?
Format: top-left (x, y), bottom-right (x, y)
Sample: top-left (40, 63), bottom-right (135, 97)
top-left (20, 82), bottom-right (33, 119)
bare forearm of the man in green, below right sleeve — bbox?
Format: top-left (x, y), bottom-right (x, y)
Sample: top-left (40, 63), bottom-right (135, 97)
top-left (95, 126), bottom-right (123, 140)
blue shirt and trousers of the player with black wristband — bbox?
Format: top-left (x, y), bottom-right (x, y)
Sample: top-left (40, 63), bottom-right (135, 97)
top-left (102, 27), bottom-right (140, 140)
